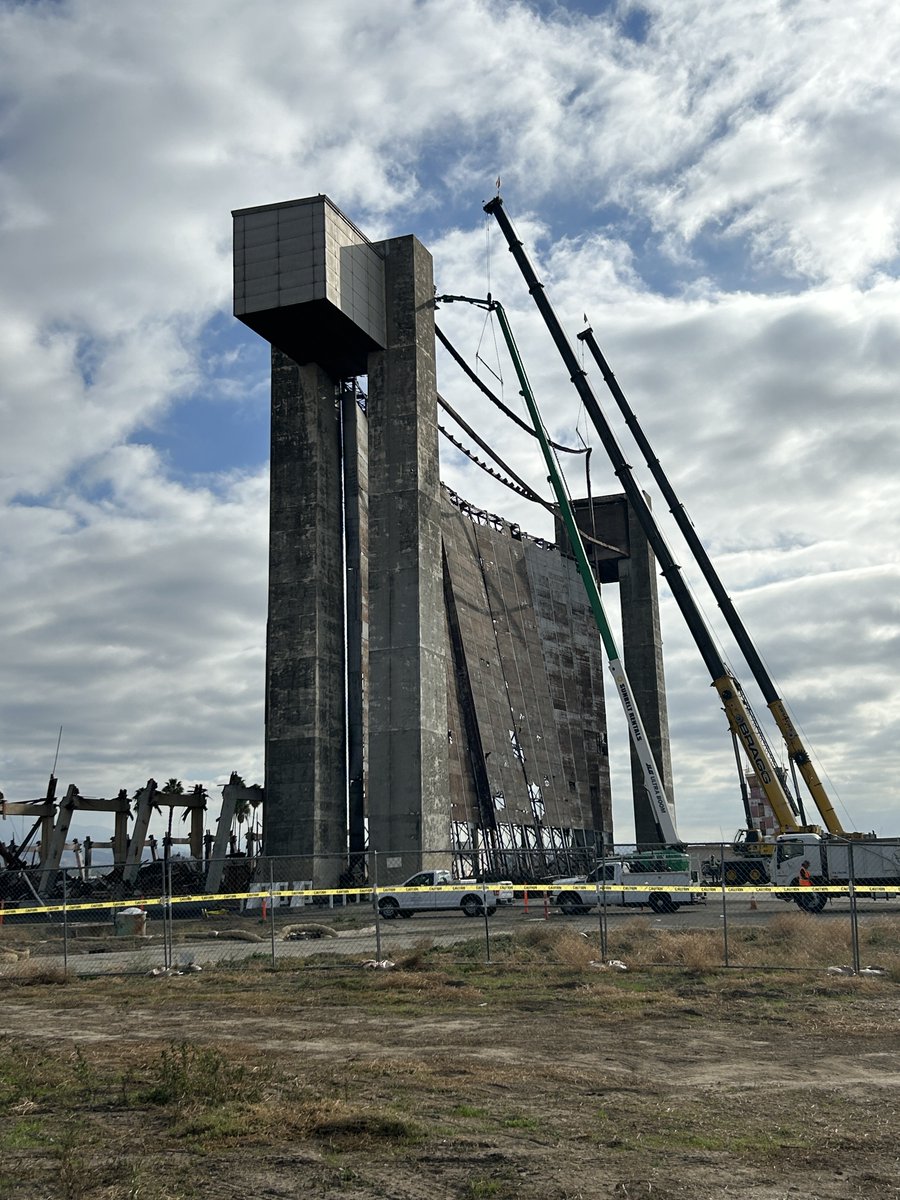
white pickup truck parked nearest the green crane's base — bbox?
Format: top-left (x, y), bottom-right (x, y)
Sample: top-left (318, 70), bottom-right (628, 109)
top-left (547, 859), bottom-right (701, 917)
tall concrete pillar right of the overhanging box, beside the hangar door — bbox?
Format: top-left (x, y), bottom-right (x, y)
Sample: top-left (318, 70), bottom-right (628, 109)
top-left (368, 236), bottom-right (450, 871)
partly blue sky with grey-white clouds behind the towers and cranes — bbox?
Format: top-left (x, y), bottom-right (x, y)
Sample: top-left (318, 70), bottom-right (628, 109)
top-left (0, 0), bottom-right (900, 841)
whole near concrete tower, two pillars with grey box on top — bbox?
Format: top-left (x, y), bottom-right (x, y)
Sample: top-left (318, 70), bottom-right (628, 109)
top-left (233, 196), bottom-right (448, 877)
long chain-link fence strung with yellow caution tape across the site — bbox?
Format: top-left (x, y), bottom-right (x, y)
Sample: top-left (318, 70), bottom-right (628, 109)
top-left (0, 844), bottom-right (900, 980)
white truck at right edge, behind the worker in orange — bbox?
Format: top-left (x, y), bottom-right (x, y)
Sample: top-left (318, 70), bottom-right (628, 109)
top-left (772, 833), bottom-right (900, 912)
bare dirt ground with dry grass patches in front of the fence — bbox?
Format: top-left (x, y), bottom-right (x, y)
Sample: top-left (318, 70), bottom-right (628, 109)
top-left (0, 961), bottom-right (900, 1200)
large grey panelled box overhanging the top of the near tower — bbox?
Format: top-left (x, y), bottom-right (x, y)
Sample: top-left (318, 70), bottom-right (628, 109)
top-left (233, 196), bottom-right (386, 378)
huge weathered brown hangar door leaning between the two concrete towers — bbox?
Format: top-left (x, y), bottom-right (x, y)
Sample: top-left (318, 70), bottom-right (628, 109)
top-left (443, 492), bottom-right (611, 830)
